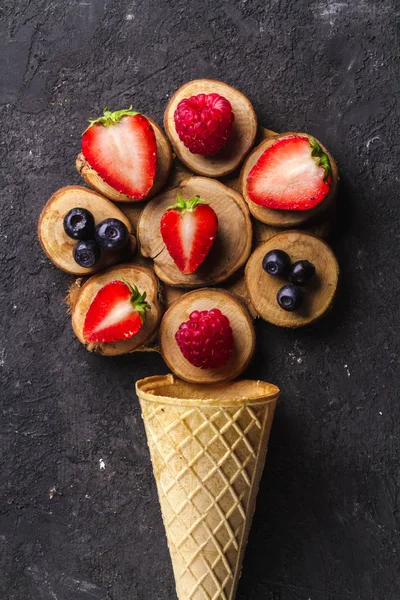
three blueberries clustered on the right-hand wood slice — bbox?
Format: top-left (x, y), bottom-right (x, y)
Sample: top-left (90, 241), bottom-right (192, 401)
top-left (263, 250), bottom-right (315, 311)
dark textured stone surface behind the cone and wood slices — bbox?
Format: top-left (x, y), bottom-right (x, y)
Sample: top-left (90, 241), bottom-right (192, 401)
top-left (0, 0), bottom-right (400, 600)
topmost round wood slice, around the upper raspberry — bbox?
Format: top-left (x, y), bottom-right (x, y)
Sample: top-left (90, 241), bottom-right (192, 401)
top-left (164, 79), bottom-right (257, 177)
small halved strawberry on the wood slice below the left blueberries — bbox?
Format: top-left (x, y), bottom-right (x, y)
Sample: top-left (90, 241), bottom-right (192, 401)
top-left (83, 281), bottom-right (150, 342)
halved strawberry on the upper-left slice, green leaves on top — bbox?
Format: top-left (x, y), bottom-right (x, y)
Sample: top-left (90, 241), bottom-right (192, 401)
top-left (82, 106), bottom-right (157, 200)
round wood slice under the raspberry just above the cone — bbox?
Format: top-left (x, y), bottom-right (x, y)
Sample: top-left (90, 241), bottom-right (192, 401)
top-left (159, 288), bottom-right (255, 383)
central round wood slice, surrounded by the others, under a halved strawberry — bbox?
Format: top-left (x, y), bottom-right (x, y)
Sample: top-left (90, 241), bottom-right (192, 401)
top-left (137, 177), bottom-right (252, 288)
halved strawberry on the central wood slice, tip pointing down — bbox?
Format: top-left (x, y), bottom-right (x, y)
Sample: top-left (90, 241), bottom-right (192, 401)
top-left (160, 194), bottom-right (218, 274)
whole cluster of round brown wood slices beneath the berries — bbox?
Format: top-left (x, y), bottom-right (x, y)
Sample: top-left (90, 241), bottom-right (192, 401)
top-left (38, 79), bottom-right (339, 383)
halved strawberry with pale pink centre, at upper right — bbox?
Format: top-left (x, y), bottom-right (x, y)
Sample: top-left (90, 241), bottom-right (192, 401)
top-left (247, 134), bottom-right (332, 210)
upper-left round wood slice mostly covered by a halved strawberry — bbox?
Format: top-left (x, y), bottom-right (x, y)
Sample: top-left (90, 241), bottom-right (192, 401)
top-left (75, 117), bottom-right (172, 202)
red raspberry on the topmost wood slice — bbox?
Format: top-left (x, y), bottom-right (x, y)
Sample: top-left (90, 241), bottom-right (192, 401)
top-left (174, 94), bottom-right (235, 156)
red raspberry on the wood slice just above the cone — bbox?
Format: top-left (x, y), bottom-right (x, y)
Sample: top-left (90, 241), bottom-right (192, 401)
top-left (175, 308), bottom-right (233, 369)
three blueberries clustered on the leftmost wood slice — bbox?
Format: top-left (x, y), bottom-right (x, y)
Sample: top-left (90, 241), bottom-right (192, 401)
top-left (63, 207), bottom-right (129, 269)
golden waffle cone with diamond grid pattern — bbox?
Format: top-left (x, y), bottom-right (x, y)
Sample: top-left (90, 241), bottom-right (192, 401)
top-left (137, 375), bottom-right (279, 600)
